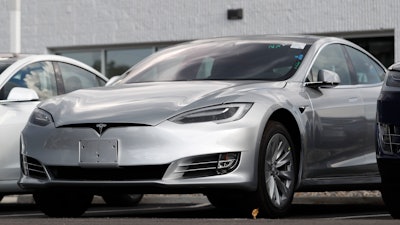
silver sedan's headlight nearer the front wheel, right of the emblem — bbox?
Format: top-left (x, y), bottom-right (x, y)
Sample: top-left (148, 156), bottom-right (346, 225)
top-left (169, 103), bottom-right (253, 124)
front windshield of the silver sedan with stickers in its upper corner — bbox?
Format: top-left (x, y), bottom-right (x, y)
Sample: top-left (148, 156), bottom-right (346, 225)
top-left (122, 40), bottom-right (309, 83)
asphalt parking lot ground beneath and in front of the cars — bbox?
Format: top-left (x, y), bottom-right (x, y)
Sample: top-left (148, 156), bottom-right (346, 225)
top-left (0, 191), bottom-right (398, 225)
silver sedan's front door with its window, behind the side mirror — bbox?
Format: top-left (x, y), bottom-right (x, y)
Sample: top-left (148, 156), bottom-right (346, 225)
top-left (303, 44), bottom-right (372, 178)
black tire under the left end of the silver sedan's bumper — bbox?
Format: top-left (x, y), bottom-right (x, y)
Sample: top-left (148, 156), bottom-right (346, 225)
top-left (33, 191), bottom-right (93, 217)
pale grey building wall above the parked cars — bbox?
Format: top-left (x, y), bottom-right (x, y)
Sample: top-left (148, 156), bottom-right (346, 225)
top-left (0, 0), bottom-right (400, 61)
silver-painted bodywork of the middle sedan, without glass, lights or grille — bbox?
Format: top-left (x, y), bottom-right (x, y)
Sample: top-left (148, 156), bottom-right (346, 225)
top-left (20, 35), bottom-right (384, 193)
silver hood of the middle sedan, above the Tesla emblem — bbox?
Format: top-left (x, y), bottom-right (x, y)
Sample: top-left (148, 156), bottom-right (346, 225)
top-left (39, 81), bottom-right (285, 127)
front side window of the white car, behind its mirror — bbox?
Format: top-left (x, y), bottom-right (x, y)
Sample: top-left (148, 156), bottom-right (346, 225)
top-left (0, 62), bottom-right (57, 100)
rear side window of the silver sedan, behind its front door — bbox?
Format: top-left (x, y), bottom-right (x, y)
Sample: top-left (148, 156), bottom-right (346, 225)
top-left (345, 46), bottom-right (385, 84)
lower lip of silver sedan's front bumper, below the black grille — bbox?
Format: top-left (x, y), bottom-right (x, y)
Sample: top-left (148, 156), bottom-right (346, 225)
top-left (19, 172), bottom-right (255, 194)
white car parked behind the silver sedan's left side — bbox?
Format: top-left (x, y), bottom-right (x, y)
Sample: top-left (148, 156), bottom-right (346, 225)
top-left (0, 54), bottom-right (108, 200)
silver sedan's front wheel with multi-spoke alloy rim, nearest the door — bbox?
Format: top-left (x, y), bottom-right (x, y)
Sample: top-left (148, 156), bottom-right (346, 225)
top-left (254, 121), bottom-right (297, 218)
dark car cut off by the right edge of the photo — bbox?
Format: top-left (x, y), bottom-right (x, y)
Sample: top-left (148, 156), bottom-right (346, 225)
top-left (377, 63), bottom-right (400, 218)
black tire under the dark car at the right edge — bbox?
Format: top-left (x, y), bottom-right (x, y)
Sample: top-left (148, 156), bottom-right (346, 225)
top-left (381, 184), bottom-right (400, 219)
